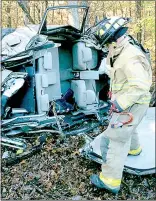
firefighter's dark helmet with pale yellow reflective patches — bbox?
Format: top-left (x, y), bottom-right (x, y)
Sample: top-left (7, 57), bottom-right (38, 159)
top-left (90, 17), bottom-right (130, 46)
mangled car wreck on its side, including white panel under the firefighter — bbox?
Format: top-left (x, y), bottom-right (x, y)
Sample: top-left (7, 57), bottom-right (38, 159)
top-left (1, 6), bottom-right (155, 174)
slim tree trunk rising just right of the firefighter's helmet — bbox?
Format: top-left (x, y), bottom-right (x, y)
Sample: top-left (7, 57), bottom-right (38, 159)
top-left (136, 0), bottom-right (142, 43)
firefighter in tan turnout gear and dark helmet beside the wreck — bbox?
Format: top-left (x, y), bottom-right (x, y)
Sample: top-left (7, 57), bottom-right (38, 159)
top-left (90, 17), bottom-right (152, 193)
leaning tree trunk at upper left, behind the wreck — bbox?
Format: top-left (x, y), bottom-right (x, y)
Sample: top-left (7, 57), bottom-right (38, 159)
top-left (18, 0), bottom-right (35, 24)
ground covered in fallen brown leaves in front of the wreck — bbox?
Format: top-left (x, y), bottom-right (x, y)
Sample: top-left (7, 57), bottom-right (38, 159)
top-left (1, 136), bottom-right (156, 200)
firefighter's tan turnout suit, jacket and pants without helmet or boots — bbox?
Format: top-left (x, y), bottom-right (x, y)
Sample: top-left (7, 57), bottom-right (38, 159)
top-left (100, 36), bottom-right (152, 183)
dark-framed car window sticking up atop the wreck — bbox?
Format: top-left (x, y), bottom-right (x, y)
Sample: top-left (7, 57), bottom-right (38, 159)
top-left (40, 6), bottom-right (87, 33)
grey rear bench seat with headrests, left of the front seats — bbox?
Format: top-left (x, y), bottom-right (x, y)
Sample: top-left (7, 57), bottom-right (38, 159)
top-left (34, 47), bottom-right (61, 114)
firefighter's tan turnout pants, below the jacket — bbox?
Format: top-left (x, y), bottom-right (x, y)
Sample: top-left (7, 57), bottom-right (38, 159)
top-left (100, 104), bottom-right (148, 182)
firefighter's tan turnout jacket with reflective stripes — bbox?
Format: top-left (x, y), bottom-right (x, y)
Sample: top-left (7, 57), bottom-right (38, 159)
top-left (107, 37), bottom-right (152, 110)
